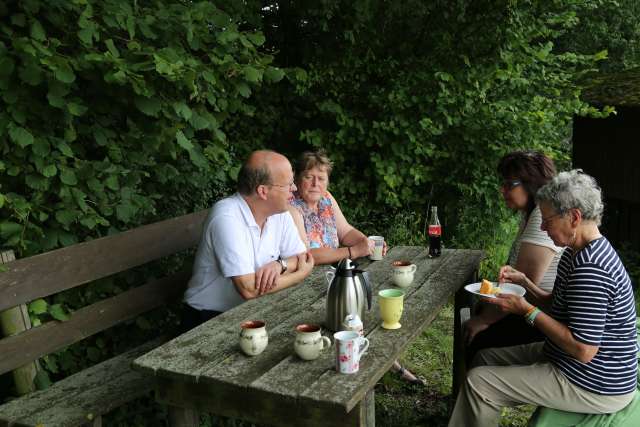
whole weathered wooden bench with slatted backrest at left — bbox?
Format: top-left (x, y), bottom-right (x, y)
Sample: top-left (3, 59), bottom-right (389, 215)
top-left (0, 210), bottom-right (207, 427)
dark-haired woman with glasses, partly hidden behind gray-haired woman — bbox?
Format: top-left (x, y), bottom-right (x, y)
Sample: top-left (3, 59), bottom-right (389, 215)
top-left (465, 151), bottom-right (561, 361)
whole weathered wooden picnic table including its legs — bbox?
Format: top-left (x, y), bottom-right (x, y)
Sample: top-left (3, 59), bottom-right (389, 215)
top-left (133, 246), bottom-right (483, 426)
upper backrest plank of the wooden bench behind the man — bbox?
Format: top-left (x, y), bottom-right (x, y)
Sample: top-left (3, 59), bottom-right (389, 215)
top-left (0, 210), bottom-right (208, 312)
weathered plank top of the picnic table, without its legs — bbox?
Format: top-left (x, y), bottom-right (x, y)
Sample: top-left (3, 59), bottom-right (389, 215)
top-left (134, 246), bottom-right (482, 418)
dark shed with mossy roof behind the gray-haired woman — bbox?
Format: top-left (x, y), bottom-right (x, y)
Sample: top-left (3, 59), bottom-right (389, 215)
top-left (573, 69), bottom-right (640, 251)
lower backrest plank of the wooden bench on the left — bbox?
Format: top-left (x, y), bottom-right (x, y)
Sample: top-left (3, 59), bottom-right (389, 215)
top-left (0, 272), bottom-right (190, 375)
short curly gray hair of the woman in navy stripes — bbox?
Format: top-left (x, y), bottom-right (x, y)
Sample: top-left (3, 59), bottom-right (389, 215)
top-left (536, 169), bottom-right (604, 225)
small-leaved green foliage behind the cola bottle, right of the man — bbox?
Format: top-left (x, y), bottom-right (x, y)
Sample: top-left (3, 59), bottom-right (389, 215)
top-left (248, 0), bottom-right (607, 256)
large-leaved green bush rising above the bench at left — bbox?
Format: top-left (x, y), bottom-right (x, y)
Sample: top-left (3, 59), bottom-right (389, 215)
top-left (0, 0), bottom-right (282, 256)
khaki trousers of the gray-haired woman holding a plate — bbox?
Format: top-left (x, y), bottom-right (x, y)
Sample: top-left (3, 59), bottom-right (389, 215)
top-left (449, 343), bottom-right (635, 427)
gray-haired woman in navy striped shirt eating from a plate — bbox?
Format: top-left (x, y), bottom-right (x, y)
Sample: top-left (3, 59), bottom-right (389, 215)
top-left (449, 170), bottom-right (638, 426)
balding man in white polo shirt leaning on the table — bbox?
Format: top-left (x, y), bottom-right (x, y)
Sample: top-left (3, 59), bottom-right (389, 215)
top-left (181, 150), bottom-right (313, 331)
